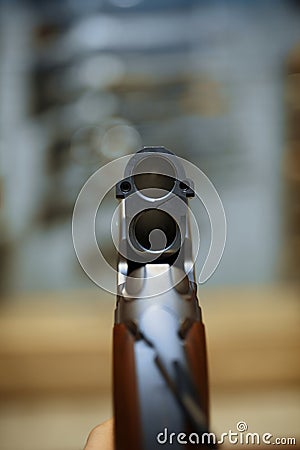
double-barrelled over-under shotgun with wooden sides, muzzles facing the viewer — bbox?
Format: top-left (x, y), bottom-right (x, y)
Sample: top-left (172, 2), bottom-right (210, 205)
top-left (113, 147), bottom-right (213, 450)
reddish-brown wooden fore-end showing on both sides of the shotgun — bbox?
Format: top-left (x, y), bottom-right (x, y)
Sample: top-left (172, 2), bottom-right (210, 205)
top-left (113, 322), bottom-right (209, 450)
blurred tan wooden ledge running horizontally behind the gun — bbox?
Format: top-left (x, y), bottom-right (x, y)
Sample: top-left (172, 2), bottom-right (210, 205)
top-left (0, 286), bottom-right (300, 394)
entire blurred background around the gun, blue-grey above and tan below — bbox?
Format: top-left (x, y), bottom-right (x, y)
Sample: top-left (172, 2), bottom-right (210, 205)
top-left (0, 0), bottom-right (300, 450)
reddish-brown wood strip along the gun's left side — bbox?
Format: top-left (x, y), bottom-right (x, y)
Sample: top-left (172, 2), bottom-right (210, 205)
top-left (113, 324), bottom-right (142, 450)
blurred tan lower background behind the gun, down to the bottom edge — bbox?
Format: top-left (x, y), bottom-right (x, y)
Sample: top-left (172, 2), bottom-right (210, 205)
top-left (0, 286), bottom-right (300, 450)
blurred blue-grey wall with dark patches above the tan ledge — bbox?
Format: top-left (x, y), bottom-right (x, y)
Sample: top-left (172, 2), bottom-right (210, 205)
top-left (0, 0), bottom-right (300, 292)
